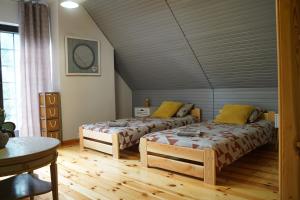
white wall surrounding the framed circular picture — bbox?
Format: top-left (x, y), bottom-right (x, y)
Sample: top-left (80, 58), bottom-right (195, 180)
top-left (49, 1), bottom-right (116, 140)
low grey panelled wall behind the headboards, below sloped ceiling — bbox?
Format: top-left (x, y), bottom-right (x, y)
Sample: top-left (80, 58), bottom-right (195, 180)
top-left (133, 88), bottom-right (278, 120)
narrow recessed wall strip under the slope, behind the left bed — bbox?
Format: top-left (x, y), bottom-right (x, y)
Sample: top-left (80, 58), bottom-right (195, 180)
top-left (115, 72), bottom-right (132, 119)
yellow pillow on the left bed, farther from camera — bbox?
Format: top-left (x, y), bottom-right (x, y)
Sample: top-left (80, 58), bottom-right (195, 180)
top-left (152, 101), bottom-right (183, 118)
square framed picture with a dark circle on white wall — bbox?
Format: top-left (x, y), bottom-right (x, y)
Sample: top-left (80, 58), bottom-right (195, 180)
top-left (65, 36), bottom-right (101, 76)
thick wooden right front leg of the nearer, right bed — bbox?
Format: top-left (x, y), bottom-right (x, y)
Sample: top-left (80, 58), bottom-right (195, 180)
top-left (204, 149), bottom-right (216, 185)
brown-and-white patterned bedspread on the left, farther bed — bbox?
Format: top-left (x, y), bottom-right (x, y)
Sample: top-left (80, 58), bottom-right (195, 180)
top-left (82, 115), bottom-right (194, 149)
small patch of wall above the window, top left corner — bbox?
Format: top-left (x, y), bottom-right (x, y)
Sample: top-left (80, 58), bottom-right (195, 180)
top-left (0, 0), bottom-right (18, 25)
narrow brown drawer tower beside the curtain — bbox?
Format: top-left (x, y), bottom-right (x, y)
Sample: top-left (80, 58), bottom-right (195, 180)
top-left (39, 92), bottom-right (62, 140)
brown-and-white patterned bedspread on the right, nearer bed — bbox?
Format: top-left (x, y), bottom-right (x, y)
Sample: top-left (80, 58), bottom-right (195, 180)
top-left (144, 120), bottom-right (274, 170)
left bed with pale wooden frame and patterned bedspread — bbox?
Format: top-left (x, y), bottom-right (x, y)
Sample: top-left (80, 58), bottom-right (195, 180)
top-left (79, 108), bottom-right (201, 159)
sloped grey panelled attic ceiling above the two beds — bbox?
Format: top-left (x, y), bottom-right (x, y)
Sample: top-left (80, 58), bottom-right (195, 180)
top-left (84, 0), bottom-right (277, 90)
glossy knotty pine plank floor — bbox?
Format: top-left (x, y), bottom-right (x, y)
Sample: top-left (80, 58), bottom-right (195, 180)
top-left (31, 145), bottom-right (279, 200)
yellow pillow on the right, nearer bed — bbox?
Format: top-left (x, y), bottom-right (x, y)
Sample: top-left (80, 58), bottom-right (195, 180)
top-left (214, 104), bottom-right (255, 125)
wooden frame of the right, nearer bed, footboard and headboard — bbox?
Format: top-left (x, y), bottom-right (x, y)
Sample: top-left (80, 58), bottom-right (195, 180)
top-left (140, 112), bottom-right (275, 185)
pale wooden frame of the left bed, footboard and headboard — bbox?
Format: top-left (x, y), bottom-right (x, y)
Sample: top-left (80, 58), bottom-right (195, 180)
top-left (79, 108), bottom-right (201, 159)
